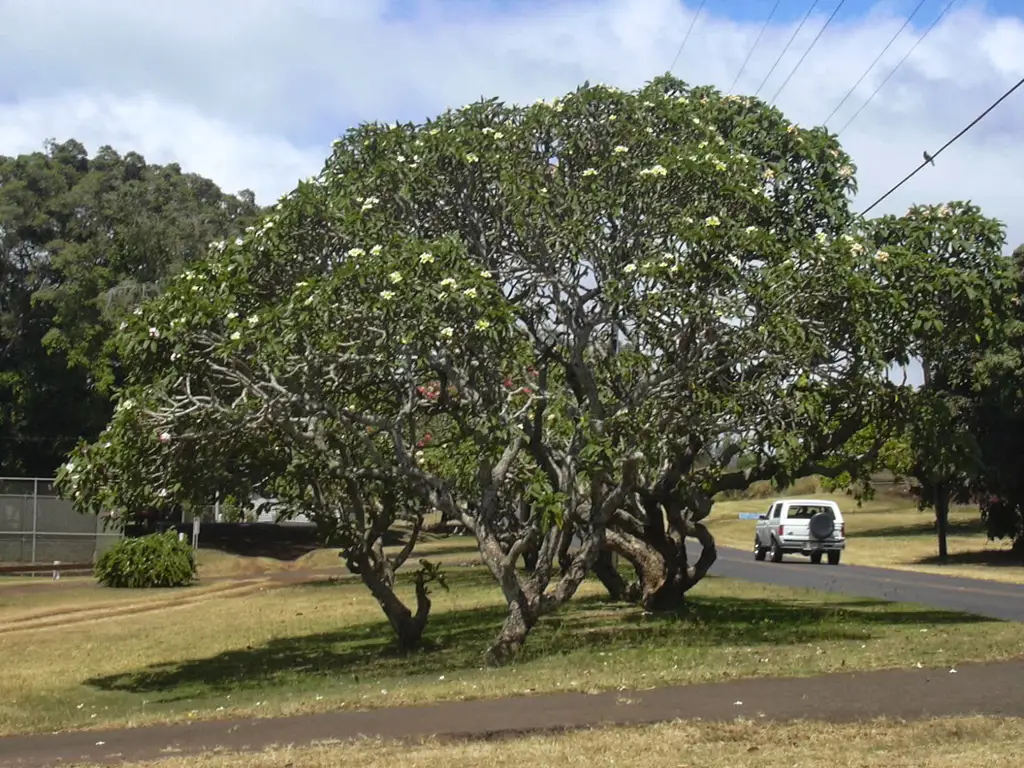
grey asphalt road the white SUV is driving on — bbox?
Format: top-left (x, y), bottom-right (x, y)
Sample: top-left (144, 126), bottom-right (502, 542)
top-left (691, 547), bottom-right (1024, 622)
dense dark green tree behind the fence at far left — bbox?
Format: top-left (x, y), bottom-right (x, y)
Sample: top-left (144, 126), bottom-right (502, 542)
top-left (0, 140), bottom-right (257, 476)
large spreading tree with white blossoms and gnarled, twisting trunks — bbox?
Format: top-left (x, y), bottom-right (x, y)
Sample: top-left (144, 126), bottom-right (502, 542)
top-left (60, 77), bottom-right (1019, 662)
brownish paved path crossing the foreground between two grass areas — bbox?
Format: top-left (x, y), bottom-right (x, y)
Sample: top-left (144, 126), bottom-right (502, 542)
top-left (0, 660), bottom-right (1024, 768)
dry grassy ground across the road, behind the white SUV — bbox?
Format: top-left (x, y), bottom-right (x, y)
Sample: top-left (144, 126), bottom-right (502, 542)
top-left (709, 493), bottom-right (1024, 584)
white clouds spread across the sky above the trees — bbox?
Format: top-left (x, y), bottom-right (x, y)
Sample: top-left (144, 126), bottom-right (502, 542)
top-left (0, 0), bottom-right (1024, 245)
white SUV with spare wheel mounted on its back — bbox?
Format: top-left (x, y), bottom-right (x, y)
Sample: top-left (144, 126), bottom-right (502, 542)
top-left (754, 499), bottom-right (846, 565)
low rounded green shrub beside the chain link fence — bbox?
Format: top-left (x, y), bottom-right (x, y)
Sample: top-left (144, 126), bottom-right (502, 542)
top-left (94, 529), bottom-right (196, 589)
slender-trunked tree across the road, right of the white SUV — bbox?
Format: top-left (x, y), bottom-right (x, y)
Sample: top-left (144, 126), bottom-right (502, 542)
top-left (869, 202), bottom-right (1014, 560)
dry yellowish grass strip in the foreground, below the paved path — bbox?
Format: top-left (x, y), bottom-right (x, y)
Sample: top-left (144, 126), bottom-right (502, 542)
top-left (70, 718), bottom-right (1024, 768)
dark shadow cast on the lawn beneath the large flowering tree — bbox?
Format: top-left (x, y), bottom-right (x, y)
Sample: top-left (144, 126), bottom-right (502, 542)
top-left (87, 574), bottom-right (983, 702)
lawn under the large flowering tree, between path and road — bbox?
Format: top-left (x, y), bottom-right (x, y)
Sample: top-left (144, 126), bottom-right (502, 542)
top-left (0, 568), bottom-right (1024, 733)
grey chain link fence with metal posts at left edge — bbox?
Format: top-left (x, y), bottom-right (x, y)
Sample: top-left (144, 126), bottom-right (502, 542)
top-left (0, 477), bottom-right (121, 564)
